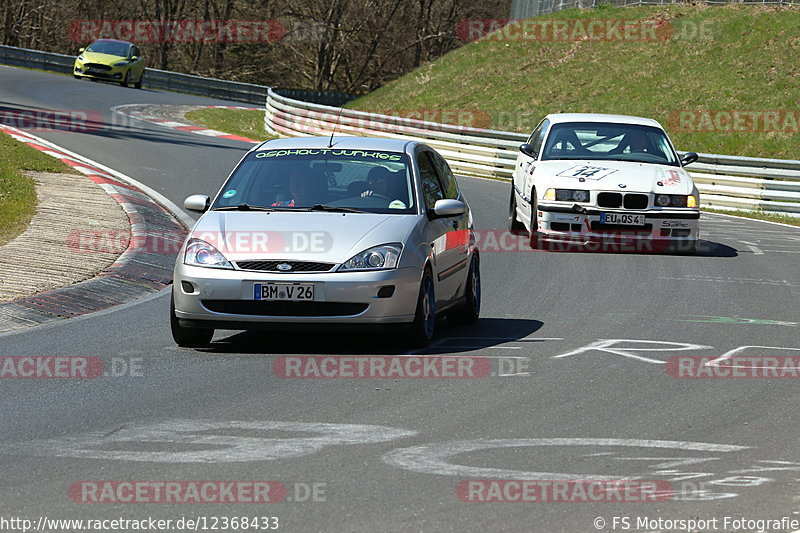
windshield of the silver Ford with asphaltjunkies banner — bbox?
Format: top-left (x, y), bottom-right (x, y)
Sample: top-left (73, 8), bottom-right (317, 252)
top-left (212, 148), bottom-right (416, 214)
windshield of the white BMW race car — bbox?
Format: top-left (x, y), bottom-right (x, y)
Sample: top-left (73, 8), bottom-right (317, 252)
top-left (542, 122), bottom-right (679, 166)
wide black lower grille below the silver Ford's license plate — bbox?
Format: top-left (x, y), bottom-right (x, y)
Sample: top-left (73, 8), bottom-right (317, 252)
top-left (205, 300), bottom-right (369, 316)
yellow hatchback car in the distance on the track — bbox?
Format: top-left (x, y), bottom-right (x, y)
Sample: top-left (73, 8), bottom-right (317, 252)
top-left (73, 39), bottom-right (145, 89)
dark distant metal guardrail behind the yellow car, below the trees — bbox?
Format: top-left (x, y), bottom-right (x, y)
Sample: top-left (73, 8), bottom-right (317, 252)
top-left (0, 45), bottom-right (356, 105)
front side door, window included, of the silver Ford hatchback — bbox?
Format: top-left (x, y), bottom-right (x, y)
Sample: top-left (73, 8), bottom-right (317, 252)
top-left (416, 149), bottom-right (465, 308)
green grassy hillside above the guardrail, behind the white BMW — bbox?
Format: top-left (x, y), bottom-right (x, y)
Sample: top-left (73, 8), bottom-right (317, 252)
top-left (347, 4), bottom-right (800, 159)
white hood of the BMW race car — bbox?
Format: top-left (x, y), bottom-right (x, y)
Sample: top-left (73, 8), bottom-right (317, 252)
top-left (536, 160), bottom-right (694, 194)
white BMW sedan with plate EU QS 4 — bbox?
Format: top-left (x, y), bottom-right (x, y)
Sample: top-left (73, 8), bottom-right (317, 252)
top-left (508, 113), bottom-right (700, 252)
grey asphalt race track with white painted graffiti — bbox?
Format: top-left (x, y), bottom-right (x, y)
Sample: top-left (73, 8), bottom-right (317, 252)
top-left (0, 67), bottom-right (800, 532)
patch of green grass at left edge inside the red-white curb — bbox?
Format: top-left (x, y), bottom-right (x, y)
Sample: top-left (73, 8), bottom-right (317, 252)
top-left (0, 134), bottom-right (75, 245)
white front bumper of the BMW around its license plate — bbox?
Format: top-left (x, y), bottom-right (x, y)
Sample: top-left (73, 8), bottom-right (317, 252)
top-left (537, 203), bottom-right (700, 242)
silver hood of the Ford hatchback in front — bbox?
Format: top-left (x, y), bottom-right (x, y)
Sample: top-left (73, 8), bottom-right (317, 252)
top-left (190, 211), bottom-right (418, 263)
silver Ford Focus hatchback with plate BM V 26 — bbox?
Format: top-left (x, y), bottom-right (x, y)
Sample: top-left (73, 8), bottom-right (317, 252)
top-left (170, 137), bottom-right (481, 347)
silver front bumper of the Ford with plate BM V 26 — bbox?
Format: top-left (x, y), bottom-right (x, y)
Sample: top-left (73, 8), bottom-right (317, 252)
top-left (173, 263), bottom-right (422, 329)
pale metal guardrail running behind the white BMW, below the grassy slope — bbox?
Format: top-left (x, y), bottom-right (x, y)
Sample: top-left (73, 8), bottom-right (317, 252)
top-left (264, 90), bottom-right (800, 216)
